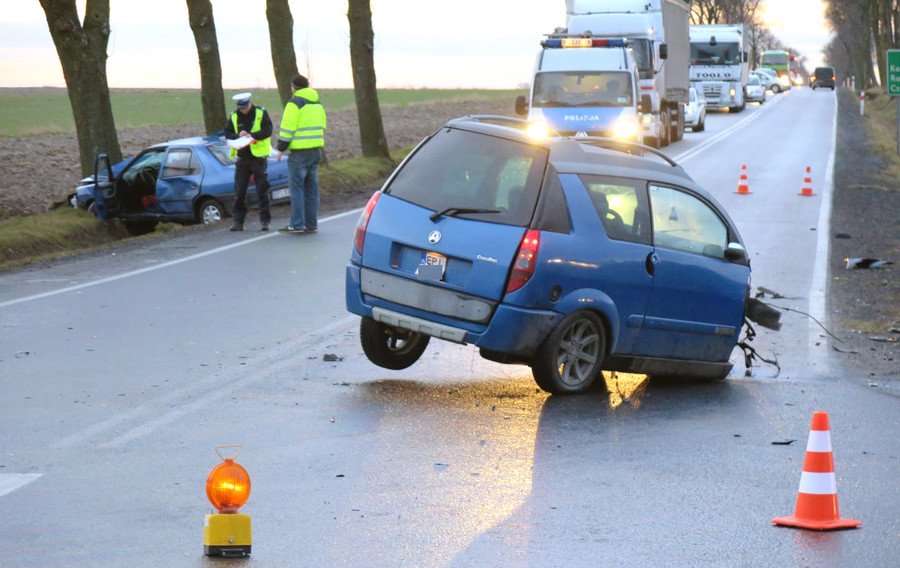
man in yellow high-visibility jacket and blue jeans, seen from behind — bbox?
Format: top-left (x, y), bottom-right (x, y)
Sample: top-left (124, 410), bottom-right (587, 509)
top-left (276, 75), bottom-right (326, 233)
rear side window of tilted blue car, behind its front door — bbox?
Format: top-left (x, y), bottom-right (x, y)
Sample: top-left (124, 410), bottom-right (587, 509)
top-left (580, 175), bottom-right (650, 244)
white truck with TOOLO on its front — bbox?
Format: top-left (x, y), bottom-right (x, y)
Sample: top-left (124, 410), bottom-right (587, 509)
top-left (691, 24), bottom-right (750, 112)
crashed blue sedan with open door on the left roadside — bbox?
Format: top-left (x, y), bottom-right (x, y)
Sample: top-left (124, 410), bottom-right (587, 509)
top-left (69, 135), bottom-right (290, 234)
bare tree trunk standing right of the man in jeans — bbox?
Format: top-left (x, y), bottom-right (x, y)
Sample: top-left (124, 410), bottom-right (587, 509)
top-left (347, 0), bottom-right (390, 159)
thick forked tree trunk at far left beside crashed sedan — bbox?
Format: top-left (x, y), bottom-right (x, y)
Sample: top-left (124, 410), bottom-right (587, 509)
top-left (41, 0), bottom-right (122, 175)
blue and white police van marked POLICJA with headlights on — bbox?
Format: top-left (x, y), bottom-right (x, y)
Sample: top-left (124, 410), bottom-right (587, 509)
top-left (516, 34), bottom-right (650, 143)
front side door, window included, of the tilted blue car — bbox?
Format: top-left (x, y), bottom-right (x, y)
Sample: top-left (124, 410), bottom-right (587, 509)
top-left (635, 183), bottom-right (750, 361)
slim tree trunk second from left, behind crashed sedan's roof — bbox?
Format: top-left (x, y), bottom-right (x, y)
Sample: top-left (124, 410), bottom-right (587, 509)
top-left (187, 0), bottom-right (228, 134)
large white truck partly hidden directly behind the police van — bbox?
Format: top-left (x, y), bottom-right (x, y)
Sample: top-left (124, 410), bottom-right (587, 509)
top-left (565, 0), bottom-right (690, 147)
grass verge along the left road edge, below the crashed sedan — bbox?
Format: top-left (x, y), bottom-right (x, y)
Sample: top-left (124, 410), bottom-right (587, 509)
top-left (0, 148), bottom-right (412, 270)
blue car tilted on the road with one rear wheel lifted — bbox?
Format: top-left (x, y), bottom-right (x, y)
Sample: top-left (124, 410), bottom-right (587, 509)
top-left (346, 113), bottom-right (750, 393)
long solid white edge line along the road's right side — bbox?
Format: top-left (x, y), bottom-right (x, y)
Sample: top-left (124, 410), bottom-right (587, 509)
top-left (807, 92), bottom-right (838, 368)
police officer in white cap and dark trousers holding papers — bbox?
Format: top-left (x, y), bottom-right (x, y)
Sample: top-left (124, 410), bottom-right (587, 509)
top-left (225, 93), bottom-right (272, 231)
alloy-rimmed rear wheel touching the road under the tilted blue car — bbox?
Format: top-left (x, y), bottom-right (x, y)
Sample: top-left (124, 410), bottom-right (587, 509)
top-left (531, 310), bottom-right (606, 394)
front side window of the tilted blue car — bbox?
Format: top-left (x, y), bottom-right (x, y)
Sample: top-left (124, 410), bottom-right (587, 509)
top-left (650, 184), bottom-right (728, 258)
